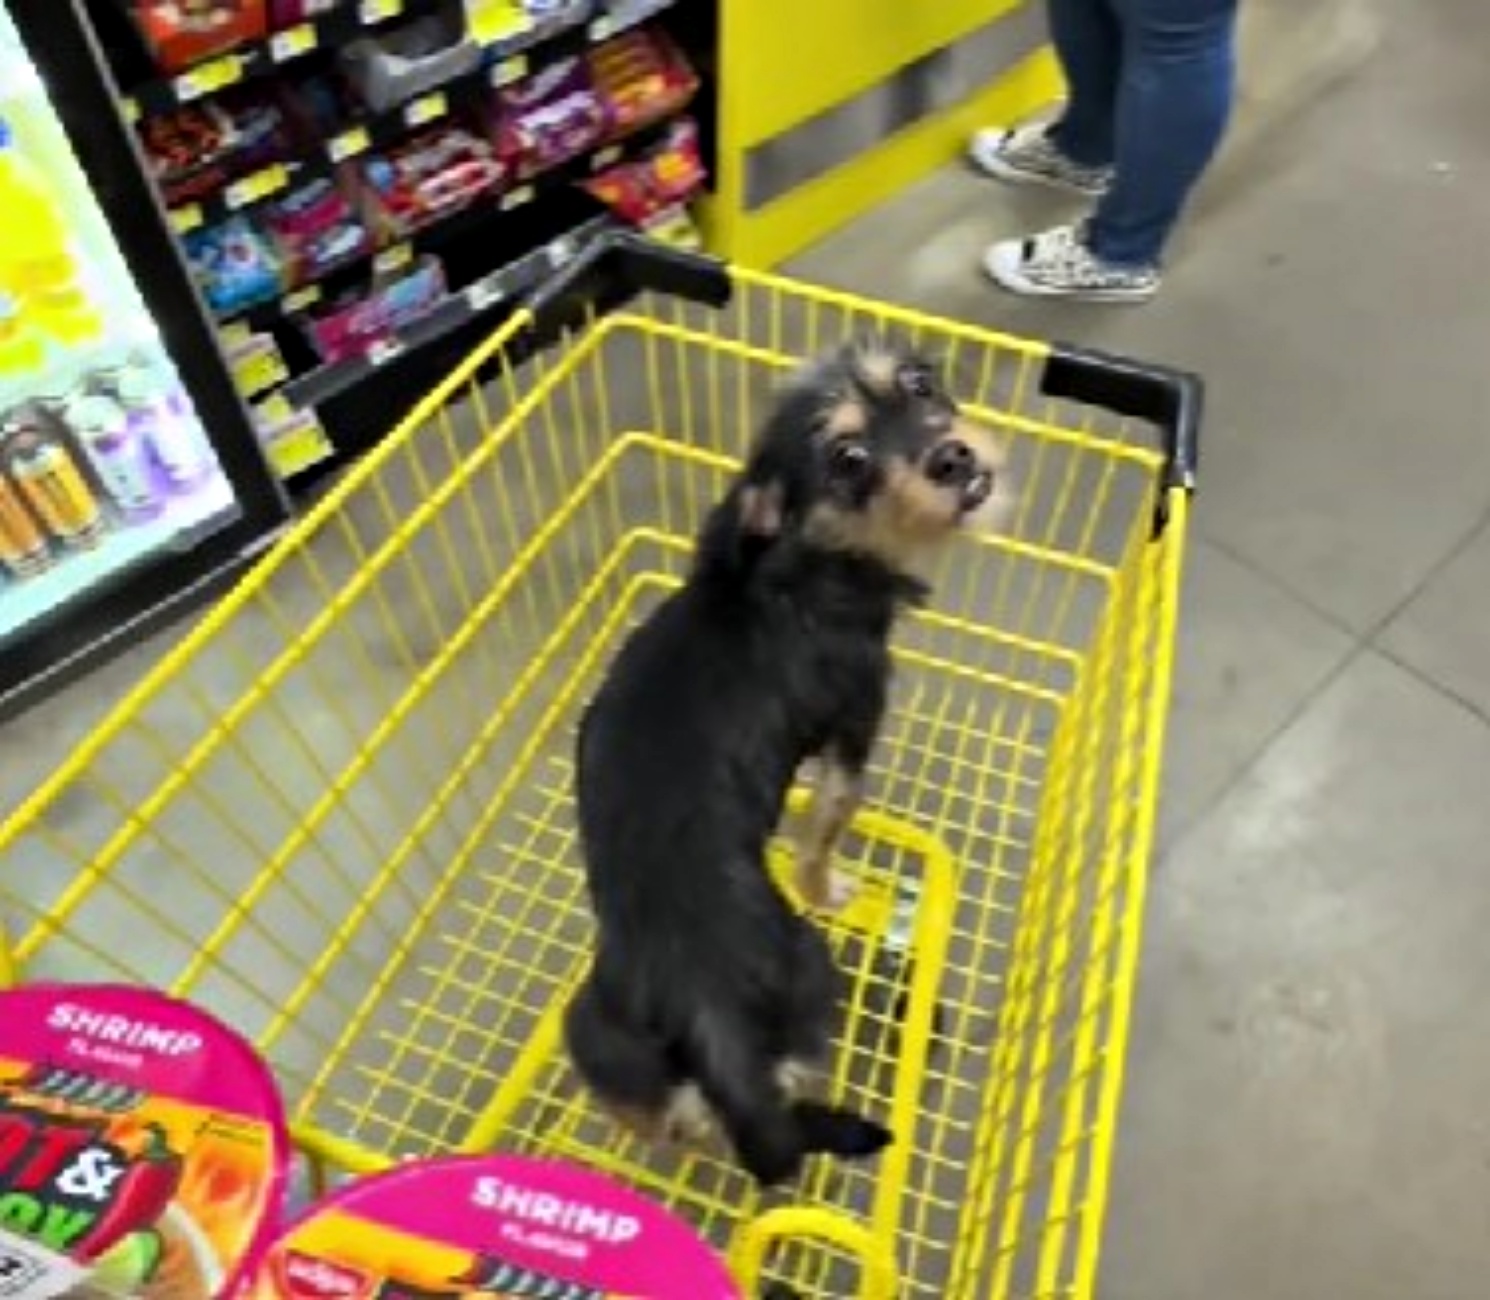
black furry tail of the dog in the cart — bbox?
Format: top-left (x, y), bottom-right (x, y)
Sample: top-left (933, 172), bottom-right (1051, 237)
top-left (691, 1015), bottom-right (893, 1187)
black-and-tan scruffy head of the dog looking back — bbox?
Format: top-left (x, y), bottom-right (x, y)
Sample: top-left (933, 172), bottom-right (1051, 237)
top-left (733, 341), bottom-right (1004, 571)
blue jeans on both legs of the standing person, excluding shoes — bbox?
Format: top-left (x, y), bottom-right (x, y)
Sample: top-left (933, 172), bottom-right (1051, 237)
top-left (1047, 0), bottom-right (1237, 267)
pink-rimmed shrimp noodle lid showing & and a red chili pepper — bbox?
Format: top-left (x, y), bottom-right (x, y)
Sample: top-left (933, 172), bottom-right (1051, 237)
top-left (0, 984), bottom-right (289, 1300)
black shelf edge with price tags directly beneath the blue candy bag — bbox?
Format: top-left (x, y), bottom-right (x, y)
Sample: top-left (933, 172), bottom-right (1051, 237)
top-left (219, 103), bottom-right (688, 329)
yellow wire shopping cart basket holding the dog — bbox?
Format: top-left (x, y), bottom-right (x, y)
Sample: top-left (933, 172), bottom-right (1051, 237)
top-left (0, 236), bottom-right (1198, 1300)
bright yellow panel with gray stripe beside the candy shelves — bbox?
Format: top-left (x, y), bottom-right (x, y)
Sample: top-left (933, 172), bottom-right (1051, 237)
top-left (705, 0), bottom-right (1059, 267)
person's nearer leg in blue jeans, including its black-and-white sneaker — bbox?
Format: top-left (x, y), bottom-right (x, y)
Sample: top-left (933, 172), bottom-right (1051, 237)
top-left (985, 0), bottom-right (1237, 301)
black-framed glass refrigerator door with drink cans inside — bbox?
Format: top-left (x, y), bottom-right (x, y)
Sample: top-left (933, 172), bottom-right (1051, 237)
top-left (0, 0), bottom-right (286, 708)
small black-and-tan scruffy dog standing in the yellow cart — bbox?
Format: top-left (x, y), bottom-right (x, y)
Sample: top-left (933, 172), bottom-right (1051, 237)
top-left (565, 344), bottom-right (1003, 1185)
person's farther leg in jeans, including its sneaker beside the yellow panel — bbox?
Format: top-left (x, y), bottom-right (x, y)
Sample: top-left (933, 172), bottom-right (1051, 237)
top-left (969, 0), bottom-right (1122, 195)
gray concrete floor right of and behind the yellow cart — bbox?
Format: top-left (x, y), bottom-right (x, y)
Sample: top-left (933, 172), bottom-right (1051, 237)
top-left (797, 0), bottom-right (1490, 1300)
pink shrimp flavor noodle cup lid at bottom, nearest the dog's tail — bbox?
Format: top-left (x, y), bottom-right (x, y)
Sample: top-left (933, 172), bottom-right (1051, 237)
top-left (244, 1155), bottom-right (741, 1300)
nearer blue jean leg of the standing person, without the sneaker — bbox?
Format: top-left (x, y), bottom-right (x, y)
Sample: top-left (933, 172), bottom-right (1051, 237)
top-left (1086, 0), bottom-right (1237, 267)
